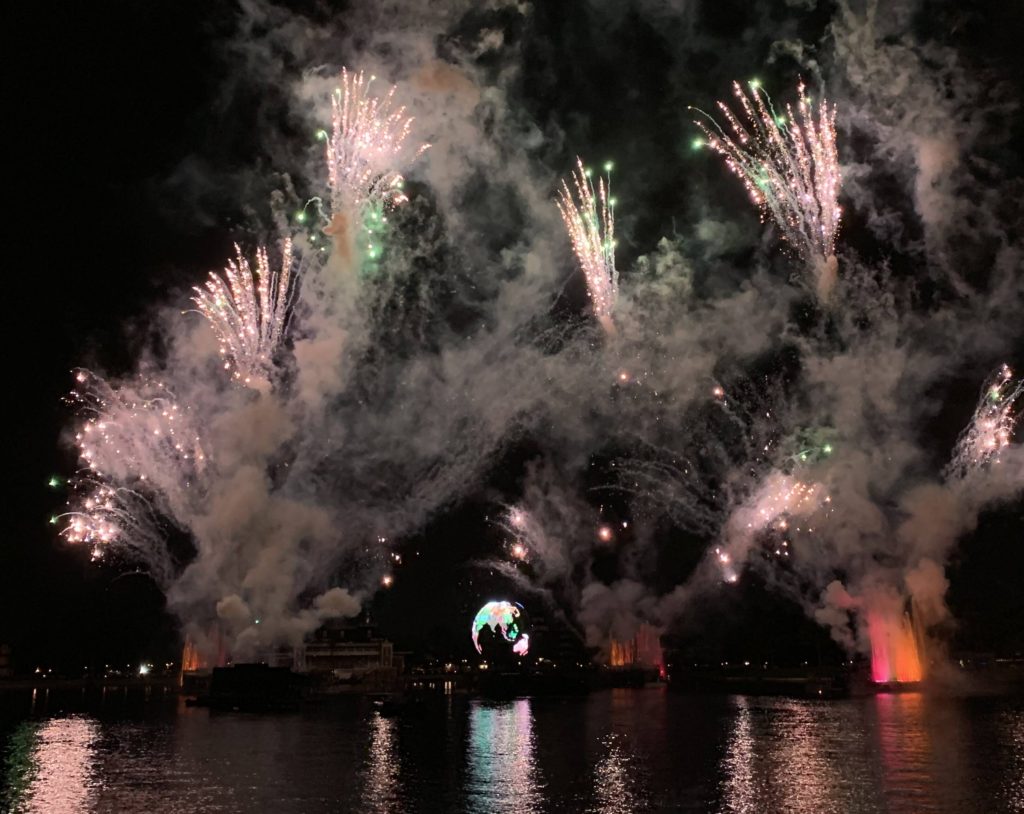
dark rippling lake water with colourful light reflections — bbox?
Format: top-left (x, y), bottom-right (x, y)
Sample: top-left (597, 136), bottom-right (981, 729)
top-left (0, 688), bottom-right (1024, 814)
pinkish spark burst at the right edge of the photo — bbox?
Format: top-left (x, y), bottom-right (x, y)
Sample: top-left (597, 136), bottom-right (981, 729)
top-left (945, 365), bottom-right (1024, 479)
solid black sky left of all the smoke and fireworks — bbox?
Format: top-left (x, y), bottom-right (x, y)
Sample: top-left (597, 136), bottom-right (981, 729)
top-left (7, 2), bottom-right (240, 667)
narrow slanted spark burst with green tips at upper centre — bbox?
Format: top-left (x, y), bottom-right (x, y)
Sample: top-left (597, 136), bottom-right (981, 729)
top-left (557, 159), bottom-right (618, 334)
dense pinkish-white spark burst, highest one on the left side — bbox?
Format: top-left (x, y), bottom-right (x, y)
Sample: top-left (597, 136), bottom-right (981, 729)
top-left (327, 69), bottom-right (429, 214)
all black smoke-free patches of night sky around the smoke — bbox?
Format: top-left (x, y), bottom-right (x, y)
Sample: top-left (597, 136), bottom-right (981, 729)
top-left (0, 0), bottom-right (1024, 670)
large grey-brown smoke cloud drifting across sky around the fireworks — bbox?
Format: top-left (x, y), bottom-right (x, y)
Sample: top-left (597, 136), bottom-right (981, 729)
top-left (68, 0), bottom-right (1024, 667)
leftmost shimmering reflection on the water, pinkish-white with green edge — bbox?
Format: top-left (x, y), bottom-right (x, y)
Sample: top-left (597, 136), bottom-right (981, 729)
top-left (5, 717), bottom-right (97, 814)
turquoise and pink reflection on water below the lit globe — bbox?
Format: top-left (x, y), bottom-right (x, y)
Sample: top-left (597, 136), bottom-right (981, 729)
top-left (466, 698), bottom-right (544, 814)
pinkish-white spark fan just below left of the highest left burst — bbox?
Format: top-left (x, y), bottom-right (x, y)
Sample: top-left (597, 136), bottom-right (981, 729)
top-left (193, 239), bottom-right (292, 387)
